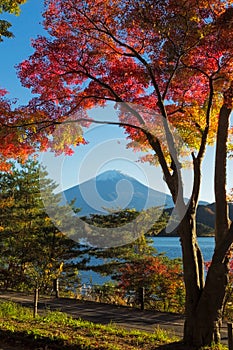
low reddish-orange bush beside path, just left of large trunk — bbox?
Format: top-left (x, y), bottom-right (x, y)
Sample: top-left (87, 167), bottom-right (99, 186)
top-left (118, 256), bottom-right (185, 312)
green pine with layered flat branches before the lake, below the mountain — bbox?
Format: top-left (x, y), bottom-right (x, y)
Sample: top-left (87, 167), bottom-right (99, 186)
top-left (83, 208), bottom-right (166, 278)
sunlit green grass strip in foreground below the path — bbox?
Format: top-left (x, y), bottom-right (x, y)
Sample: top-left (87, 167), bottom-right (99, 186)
top-left (0, 302), bottom-right (228, 350)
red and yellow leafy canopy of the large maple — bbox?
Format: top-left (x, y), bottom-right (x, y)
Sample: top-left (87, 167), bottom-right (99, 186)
top-left (15, 0), bottom-right (232, 165)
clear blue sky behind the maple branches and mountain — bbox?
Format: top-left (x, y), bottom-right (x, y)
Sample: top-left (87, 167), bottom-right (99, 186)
top-left (0, 0), bottom-right (233, 202)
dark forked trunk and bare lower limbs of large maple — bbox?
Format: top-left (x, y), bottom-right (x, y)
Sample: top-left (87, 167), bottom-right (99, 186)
top-left (149, 80), bottom-right (233, 347)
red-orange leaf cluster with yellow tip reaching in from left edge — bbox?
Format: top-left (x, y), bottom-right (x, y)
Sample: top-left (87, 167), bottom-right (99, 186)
top-left (0, 90), bottom-right (85, 171)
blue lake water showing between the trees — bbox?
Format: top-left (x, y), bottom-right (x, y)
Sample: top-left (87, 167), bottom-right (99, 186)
top-left (80, 237), bottom-right (214, 284)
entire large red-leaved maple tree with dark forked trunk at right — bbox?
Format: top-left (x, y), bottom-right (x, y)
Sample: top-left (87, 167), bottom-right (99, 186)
top-left (15, 0), bottom-right (233, 346)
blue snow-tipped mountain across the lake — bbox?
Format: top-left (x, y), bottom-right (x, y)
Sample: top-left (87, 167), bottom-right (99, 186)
top-left (63, 170), bottom-right (173, 216)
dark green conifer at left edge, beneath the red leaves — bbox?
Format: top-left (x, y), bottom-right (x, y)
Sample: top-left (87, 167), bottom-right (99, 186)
top-left (0, 160), bottom-right (87, 292)
